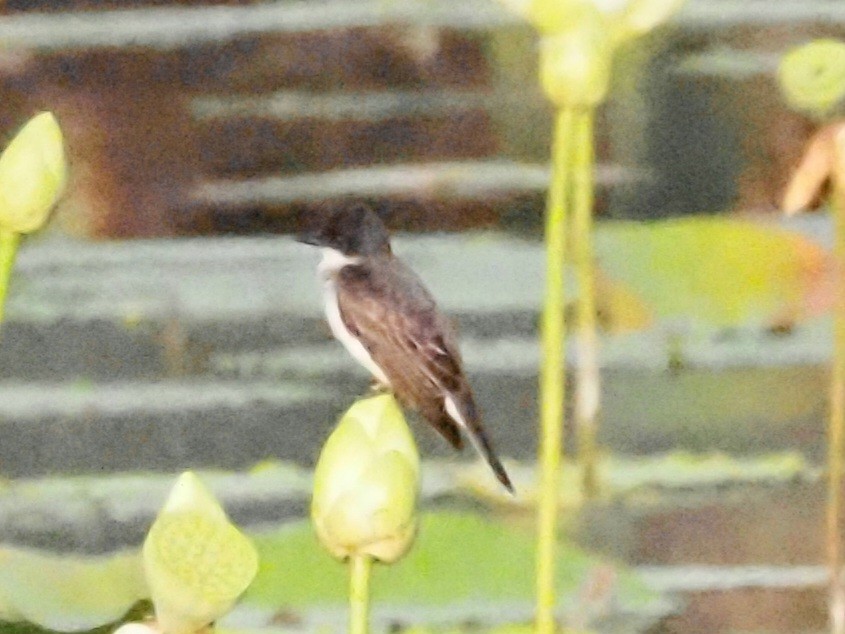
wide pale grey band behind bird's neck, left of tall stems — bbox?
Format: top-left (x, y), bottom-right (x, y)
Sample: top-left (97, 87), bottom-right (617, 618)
top-left (1, 230), bottom-right (543, 330)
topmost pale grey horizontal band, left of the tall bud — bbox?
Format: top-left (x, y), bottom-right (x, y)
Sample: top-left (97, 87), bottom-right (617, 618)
top-left (0, 0), bottom-right (508, 51)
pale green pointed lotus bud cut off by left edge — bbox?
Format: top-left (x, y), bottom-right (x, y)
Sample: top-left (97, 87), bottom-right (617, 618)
top-left (0, 112), bottom-right (67, 233)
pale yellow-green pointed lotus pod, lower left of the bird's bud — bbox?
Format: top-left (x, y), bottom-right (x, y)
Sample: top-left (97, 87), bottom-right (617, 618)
top-left (143, 471), bottom-right (258, 634)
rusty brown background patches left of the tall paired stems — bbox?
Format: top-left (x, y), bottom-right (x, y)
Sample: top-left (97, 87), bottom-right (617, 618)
top-left (0, 21), bottom-right (504, 238)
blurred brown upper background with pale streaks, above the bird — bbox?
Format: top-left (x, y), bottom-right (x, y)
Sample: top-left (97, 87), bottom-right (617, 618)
top-left (0, 0), bottom-right (842, 237)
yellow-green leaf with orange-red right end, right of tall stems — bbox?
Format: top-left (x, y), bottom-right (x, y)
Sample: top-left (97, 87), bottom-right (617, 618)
top-left (596, 217), bottom-right (833, 326)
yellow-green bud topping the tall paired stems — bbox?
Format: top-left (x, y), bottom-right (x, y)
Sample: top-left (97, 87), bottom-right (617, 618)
top-left (540, 11), bottom-right (613, 108)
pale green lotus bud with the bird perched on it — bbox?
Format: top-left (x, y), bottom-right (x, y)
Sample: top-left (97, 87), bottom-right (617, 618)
top-left (311, 394), bottom-right (420, 562)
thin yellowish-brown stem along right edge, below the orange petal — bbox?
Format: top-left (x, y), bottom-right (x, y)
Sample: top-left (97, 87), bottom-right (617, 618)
top-left (825, 180), bottom-right (845, 634)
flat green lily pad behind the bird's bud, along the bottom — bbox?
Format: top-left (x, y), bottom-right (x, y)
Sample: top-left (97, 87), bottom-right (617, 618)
top-left (244, 512), bottom-right (656, 611)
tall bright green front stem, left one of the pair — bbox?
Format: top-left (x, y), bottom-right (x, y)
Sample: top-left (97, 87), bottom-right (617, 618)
top-left (536, 108), bottom-right (575, 634)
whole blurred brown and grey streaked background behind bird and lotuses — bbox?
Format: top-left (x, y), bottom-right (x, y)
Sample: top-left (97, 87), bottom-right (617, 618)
top-left (0, 0), bottom-right (845, 633)
